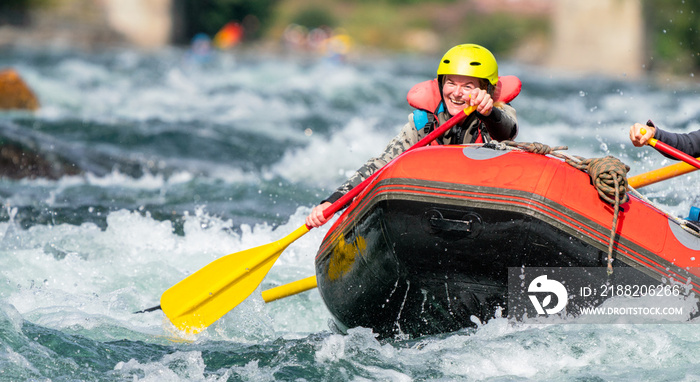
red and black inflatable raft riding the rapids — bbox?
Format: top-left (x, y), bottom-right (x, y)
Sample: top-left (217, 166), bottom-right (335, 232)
top-left (316, 146), bottom-right (700, 337)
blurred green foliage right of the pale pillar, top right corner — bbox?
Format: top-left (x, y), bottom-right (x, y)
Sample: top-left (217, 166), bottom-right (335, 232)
top-left (644, 0), bottom-right (700, 73)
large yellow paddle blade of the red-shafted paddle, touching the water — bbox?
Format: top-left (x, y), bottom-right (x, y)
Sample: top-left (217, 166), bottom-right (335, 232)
top-left (160, 225), bottom-right (309, 333)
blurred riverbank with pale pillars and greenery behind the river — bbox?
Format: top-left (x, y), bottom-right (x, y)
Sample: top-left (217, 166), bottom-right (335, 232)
top-left (0, 0), bottom-right (700, 78)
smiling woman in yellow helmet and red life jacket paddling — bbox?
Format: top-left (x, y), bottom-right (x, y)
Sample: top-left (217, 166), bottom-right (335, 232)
top-left (306, 44), bottom-right (519, 227)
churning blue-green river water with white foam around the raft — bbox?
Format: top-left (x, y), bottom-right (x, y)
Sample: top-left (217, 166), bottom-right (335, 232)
top-left (0, 49), bottom-right (700, 381)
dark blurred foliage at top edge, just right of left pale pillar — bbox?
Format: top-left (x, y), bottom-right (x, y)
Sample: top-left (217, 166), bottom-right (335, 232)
top-left (182, 0), bottom-right (278, 39)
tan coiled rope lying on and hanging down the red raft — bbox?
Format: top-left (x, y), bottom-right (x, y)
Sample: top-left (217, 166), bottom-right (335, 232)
top-left (496, 141), bottom-right (630, 274)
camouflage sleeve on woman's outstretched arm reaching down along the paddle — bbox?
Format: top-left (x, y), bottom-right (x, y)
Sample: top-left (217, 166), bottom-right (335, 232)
top-left (324, 114), bottom-right (419, 203)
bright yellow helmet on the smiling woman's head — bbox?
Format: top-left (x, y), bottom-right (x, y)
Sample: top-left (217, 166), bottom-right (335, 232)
top-left (437, 44), bottom-right (498, 86)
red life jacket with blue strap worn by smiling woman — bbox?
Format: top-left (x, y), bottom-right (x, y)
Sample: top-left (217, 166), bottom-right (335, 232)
top-left (406, 76), bottom-right (523, 143)
